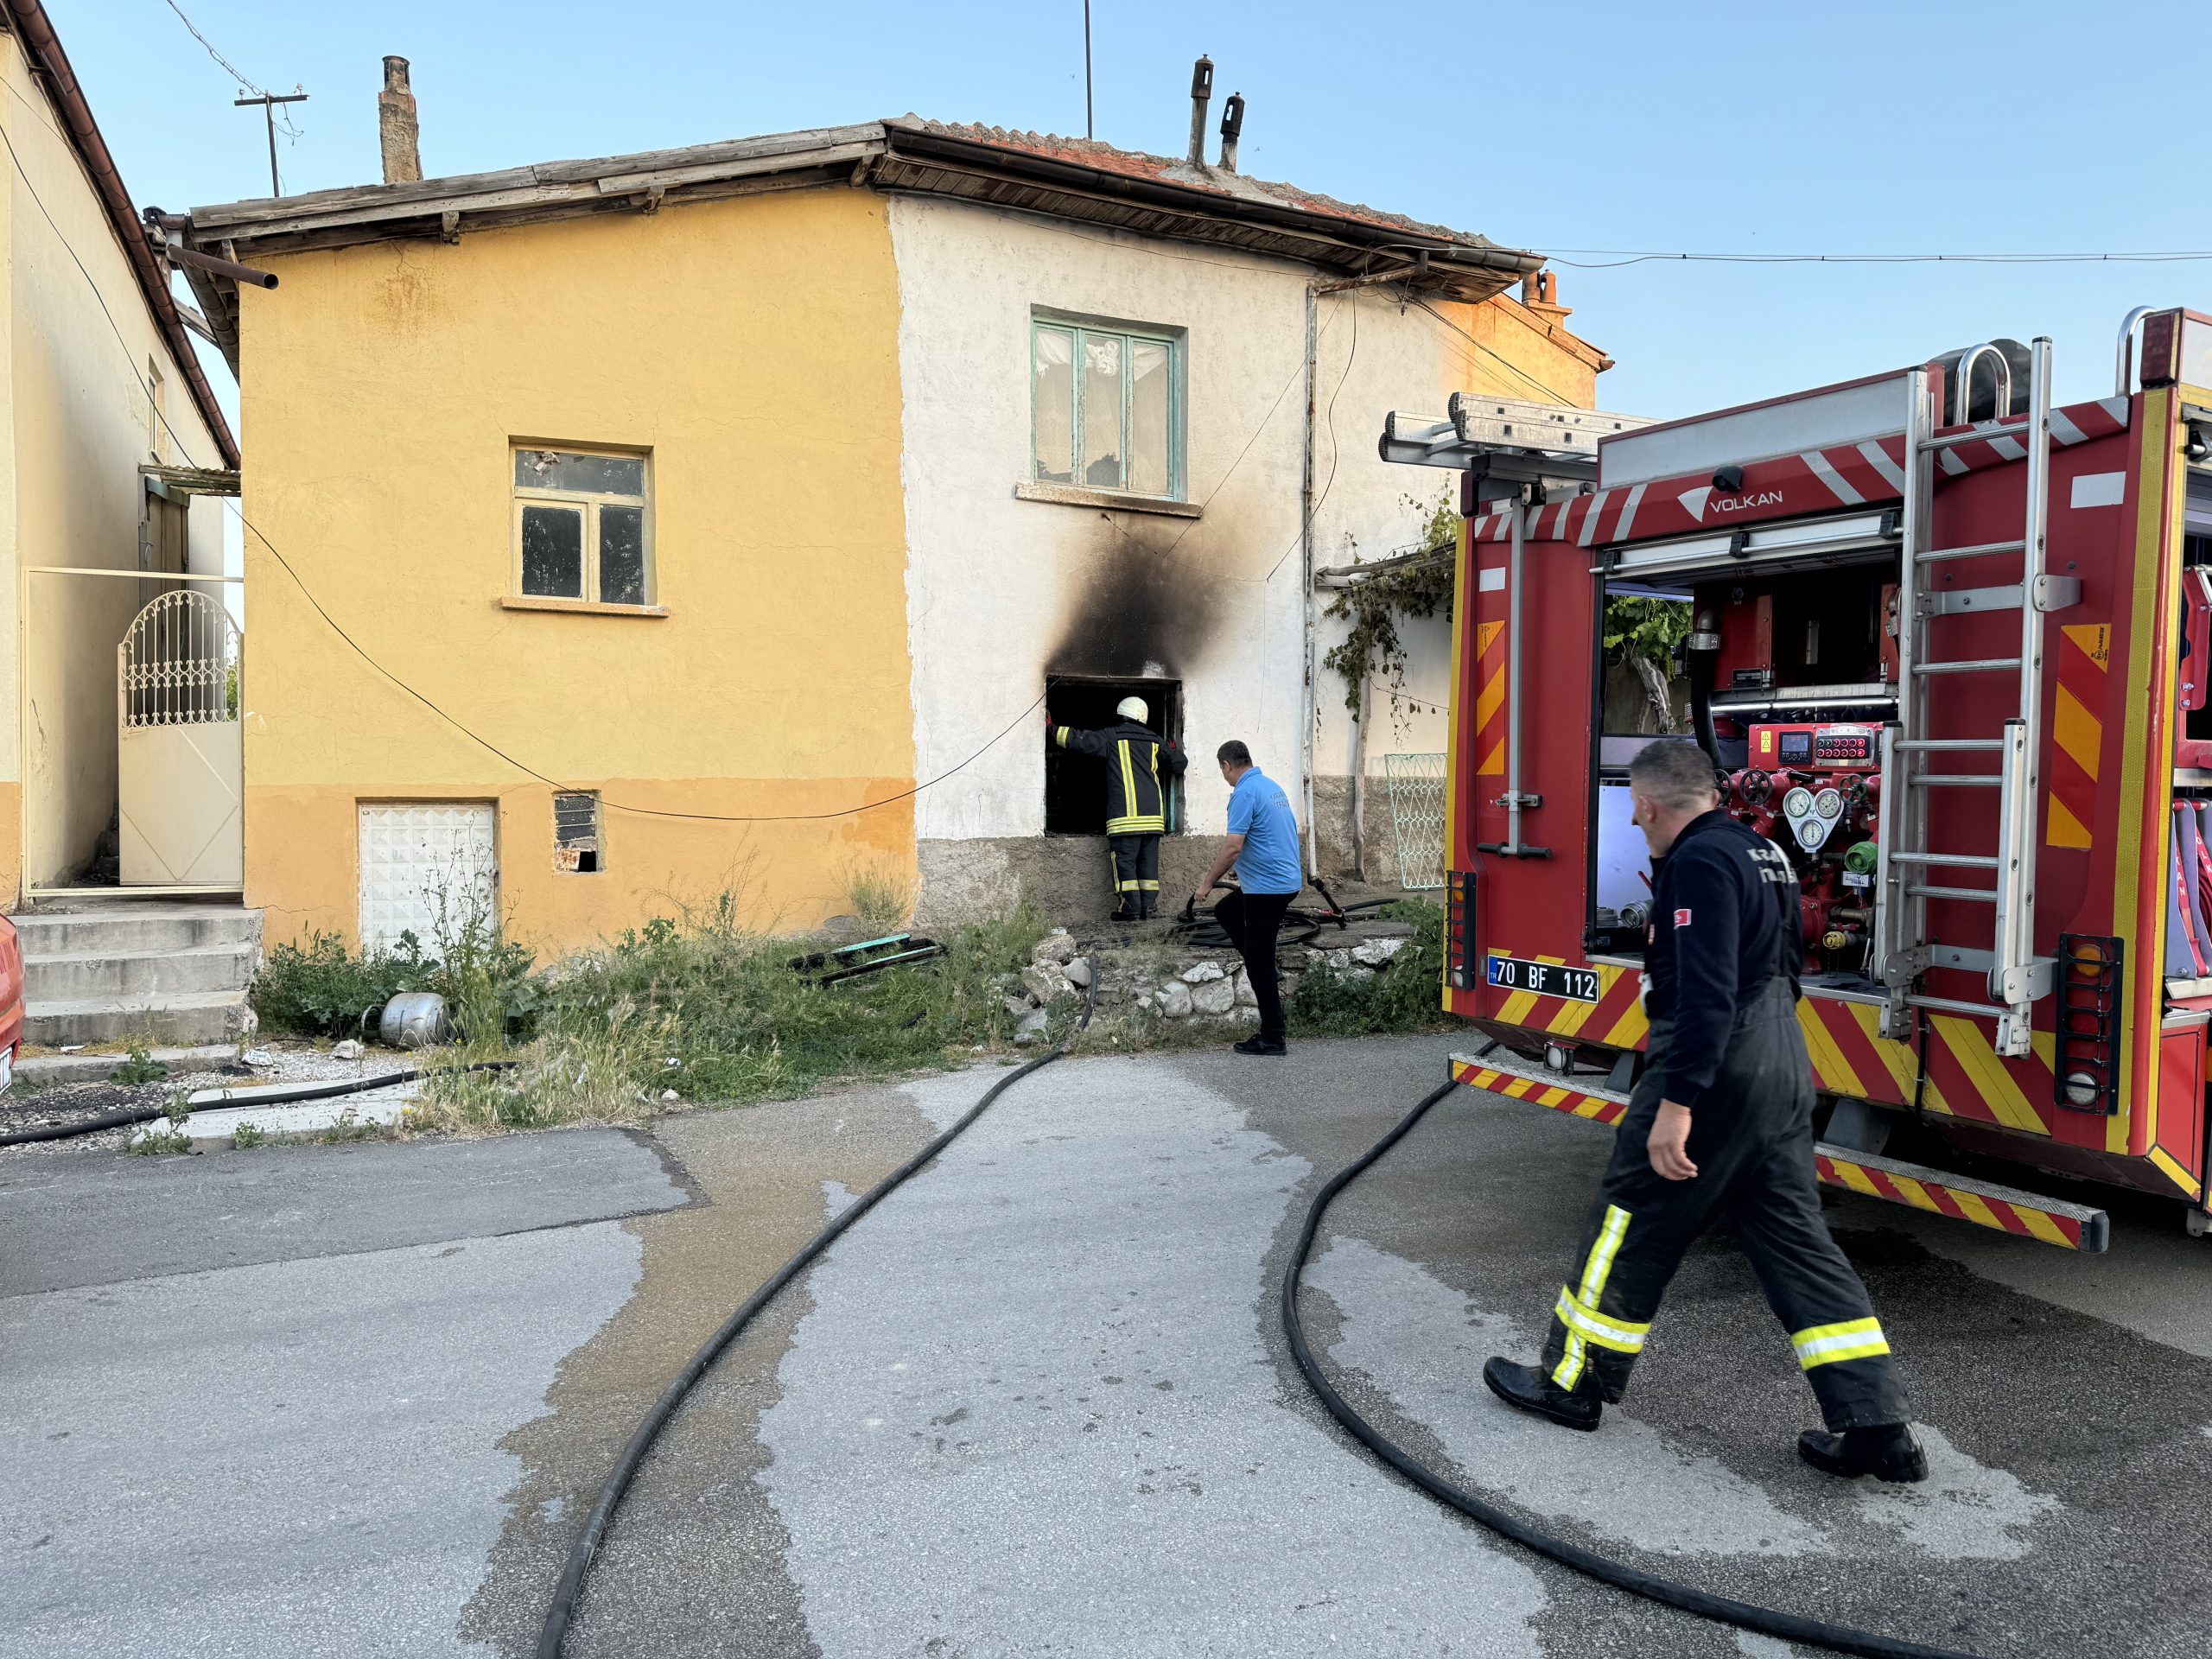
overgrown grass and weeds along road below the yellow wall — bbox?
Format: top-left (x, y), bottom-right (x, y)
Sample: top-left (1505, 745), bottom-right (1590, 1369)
top-left (410, 893), bottom-right (1071, 1130)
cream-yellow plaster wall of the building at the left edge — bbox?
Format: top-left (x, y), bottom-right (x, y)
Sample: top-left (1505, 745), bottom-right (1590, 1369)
top-left (0, 35), bottom-right (224, 905)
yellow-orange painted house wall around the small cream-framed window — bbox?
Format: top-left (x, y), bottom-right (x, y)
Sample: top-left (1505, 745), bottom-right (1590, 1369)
top-left (241, 188), bottom-right (913, 953)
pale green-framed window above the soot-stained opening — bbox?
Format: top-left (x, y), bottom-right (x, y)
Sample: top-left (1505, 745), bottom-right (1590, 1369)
top-left (1028, 316), bottom-right (1184, 500)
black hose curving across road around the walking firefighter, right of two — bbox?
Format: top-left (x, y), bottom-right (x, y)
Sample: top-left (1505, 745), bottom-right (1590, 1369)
top-left (1283, 1079), bottom-right (1974, 1659)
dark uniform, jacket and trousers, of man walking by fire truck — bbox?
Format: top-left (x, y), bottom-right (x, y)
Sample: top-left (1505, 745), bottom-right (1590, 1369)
top-left (1541, 812), bottom-right (1907, 1433)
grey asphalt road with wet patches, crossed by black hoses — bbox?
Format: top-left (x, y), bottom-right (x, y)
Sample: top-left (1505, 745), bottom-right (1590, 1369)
top-left (0, 1039), bottom-right (2212, 1659)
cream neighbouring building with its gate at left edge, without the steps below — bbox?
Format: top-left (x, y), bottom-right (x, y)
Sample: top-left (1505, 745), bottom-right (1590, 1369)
top-left (0, 0), bottom-right (238, 911)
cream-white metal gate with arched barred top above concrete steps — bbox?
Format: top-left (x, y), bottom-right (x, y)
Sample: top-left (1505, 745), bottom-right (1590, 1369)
top-left (115, 588), bottom-right (245, 887)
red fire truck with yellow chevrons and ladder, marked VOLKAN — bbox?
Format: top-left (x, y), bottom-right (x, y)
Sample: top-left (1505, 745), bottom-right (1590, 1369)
top-left (1382, 308), bottom-right (2212, 1252)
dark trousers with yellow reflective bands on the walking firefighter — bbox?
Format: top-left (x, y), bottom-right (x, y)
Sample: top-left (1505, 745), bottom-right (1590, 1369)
top-left (1541, 978), bottom-right (1907, 1433)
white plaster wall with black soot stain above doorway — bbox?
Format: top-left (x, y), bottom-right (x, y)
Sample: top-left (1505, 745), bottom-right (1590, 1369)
top-left (892, 197), bottom-right (1465, 841)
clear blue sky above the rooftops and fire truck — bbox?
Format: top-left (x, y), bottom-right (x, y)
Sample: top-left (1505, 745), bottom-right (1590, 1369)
top-left (47, 0), bottom-right (2212, 429)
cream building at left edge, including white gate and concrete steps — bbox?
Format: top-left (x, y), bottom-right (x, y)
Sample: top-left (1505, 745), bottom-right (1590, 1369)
top-left (0, 0), bottom-right (259, 1044)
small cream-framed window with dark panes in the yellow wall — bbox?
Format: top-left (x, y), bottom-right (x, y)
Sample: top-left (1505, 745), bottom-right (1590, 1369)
top-left (515, 445), bottom-right (652, 604)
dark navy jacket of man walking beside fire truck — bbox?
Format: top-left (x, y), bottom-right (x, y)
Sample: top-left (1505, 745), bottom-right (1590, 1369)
top-left (1643, 812), bottom-right (1805, 1109)
